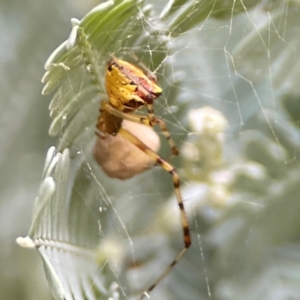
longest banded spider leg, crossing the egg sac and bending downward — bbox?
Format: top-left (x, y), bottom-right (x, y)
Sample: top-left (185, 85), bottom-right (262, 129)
top-left (119, 128), bottom-right (191, 299)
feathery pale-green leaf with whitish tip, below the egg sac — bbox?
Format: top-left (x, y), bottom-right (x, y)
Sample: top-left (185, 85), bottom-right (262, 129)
top-left (18, 148), bottom-right (110, 300)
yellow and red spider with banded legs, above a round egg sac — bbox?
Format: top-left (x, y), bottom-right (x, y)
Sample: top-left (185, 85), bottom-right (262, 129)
top-left (96, 57), bottom-right (191, 299)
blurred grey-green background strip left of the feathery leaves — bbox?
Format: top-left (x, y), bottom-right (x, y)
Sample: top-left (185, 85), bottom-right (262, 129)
top-left (0, 0), bottom-right (96, 300)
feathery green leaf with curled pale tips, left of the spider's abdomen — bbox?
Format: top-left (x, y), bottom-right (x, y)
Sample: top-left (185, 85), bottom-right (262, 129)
top-left (42, 1), bottom-right (143, 149)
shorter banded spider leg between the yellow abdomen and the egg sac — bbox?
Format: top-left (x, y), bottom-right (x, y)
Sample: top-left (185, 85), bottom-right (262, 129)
top-left (102, 102), bottom-right (179, 155)
